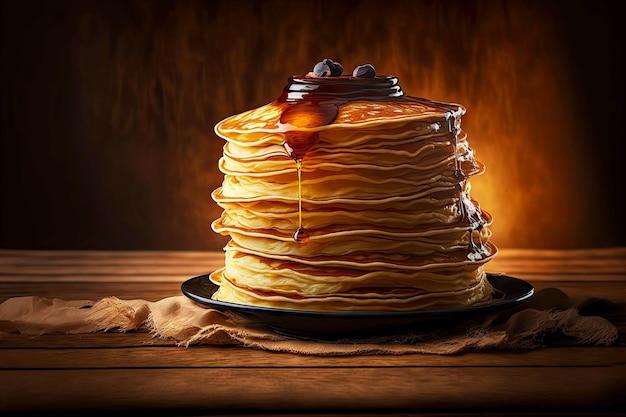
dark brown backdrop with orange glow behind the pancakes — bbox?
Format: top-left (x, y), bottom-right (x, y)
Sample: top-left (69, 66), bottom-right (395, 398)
top-left (0, 0), bottom-right (626, 250)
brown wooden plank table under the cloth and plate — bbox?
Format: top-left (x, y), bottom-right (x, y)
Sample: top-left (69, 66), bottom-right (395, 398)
top-left (0, 248), bottom-right (626, 415)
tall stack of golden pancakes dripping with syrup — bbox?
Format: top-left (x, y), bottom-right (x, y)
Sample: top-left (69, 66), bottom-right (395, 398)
top-left (210, 76), bottom-right (497, 311)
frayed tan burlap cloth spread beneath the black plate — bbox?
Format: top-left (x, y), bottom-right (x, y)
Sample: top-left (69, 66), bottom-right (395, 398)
top-left (0, 288), bottom-right (624, 356)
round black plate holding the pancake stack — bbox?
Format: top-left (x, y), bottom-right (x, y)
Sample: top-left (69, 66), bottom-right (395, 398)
top-left (181, 274), bottom-right (535, 340)
